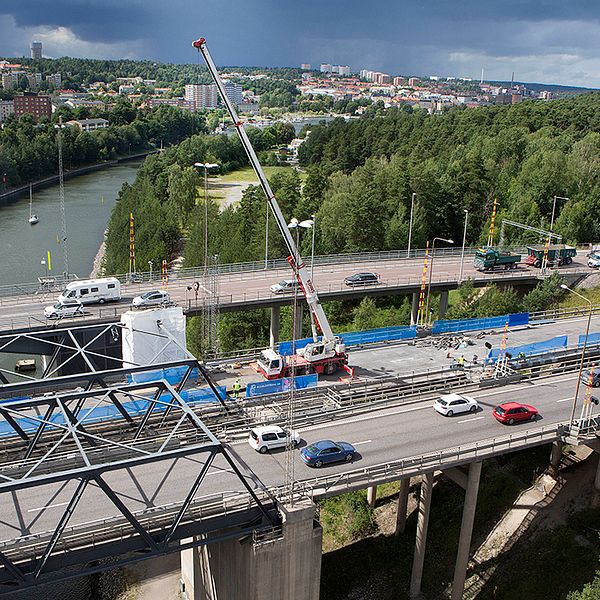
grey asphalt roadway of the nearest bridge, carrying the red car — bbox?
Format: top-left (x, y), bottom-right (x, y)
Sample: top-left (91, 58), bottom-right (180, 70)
top-left (0, 374), bottom-right (583, 540)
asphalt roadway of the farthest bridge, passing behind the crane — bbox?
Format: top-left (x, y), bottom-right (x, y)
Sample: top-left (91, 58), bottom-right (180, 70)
top-left (0, 252), bottom-right (589, 331)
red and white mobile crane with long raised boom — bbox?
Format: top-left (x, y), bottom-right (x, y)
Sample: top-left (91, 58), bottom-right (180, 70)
top-left (192, 38), bottom-right (348, 379)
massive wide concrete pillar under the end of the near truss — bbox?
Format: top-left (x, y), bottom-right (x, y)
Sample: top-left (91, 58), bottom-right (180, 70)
top-left (181, 501), bottom-right (323, 600)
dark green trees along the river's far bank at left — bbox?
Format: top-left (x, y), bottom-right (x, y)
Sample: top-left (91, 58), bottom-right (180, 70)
top-left (0, 99), bottom-right (206, 187)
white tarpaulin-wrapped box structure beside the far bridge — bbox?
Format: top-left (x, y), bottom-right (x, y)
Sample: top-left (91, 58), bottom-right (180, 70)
top-left (121, 306), bottom-right (189, 367)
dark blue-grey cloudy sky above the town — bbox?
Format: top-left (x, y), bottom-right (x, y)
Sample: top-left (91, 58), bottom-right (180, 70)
top-left (0, 0), bottom-right (600, 87)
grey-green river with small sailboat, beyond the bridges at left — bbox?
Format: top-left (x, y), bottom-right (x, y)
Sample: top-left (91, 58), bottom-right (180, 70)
top-left (0, 160), bottom-right (142, 285)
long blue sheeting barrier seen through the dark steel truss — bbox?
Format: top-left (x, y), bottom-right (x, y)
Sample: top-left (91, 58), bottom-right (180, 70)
top-left (0, 386), bottom-right (226, 436)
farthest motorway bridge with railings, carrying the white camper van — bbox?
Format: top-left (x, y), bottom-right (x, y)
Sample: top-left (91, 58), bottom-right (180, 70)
top-left (0, 249), bottom-right (591, 337)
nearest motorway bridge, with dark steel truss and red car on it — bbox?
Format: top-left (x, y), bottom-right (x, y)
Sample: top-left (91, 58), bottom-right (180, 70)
top-left (0, 324), bottom-right (598, 597)
